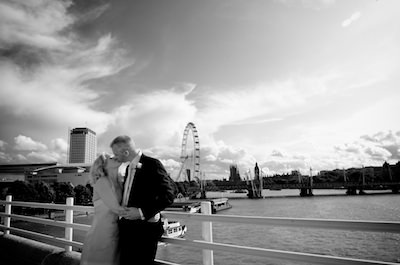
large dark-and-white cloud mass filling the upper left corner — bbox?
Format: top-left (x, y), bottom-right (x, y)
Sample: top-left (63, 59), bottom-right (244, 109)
top-left (0, 0), bottom-right (134, 144)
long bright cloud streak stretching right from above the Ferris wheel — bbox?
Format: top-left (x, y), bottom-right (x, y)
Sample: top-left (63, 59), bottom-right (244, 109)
top-left (189, 74), bottom-right (335, 136)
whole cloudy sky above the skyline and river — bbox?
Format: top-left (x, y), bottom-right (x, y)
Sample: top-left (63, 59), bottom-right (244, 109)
top-left (0, 0), bottom-right (400, 179)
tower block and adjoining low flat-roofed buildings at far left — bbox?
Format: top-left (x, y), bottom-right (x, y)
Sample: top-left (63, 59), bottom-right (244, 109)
top-left (0, 128), bottom-right (97, 186)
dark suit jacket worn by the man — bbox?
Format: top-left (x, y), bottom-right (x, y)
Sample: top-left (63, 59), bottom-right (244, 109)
top-left (127, 154), bottom-right (175, 220)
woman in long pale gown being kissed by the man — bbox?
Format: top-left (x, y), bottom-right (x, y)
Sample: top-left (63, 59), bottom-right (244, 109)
top-left (80, 154), bottom-right (125, 265)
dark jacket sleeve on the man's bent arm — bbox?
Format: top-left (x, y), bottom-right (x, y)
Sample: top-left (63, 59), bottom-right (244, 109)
top-left (141, 160), bottom-right (175, 220)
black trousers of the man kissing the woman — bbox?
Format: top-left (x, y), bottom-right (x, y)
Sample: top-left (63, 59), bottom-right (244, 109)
top-left (118, 218), bottom-right (164, 265)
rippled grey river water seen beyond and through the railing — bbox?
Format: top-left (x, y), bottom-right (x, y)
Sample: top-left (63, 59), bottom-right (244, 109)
top-left (157, 190), bottom-right (400, 265)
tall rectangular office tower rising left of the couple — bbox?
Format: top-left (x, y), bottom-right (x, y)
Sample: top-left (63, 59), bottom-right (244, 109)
top-left (68, 128), bottom-right (97, 163)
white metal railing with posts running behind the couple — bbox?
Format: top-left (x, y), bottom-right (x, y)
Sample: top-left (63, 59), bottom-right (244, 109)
top-left (0, 196), bottom-right (400, 265)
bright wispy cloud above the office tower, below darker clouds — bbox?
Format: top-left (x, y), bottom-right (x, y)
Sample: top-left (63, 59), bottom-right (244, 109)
top-left (0, 35), bottom-right (125, 133)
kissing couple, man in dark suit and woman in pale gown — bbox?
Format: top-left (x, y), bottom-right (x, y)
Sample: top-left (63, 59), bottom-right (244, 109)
top-left (80, 135), bottom-right (175, 265)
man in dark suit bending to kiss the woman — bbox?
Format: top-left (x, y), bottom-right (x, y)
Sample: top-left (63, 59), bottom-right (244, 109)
top-left (110, 135), bottom-right (175, 265)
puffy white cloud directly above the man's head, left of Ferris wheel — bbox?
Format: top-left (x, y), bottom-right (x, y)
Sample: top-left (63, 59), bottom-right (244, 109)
top-left (100, 85), bottom-right (196, 150)
